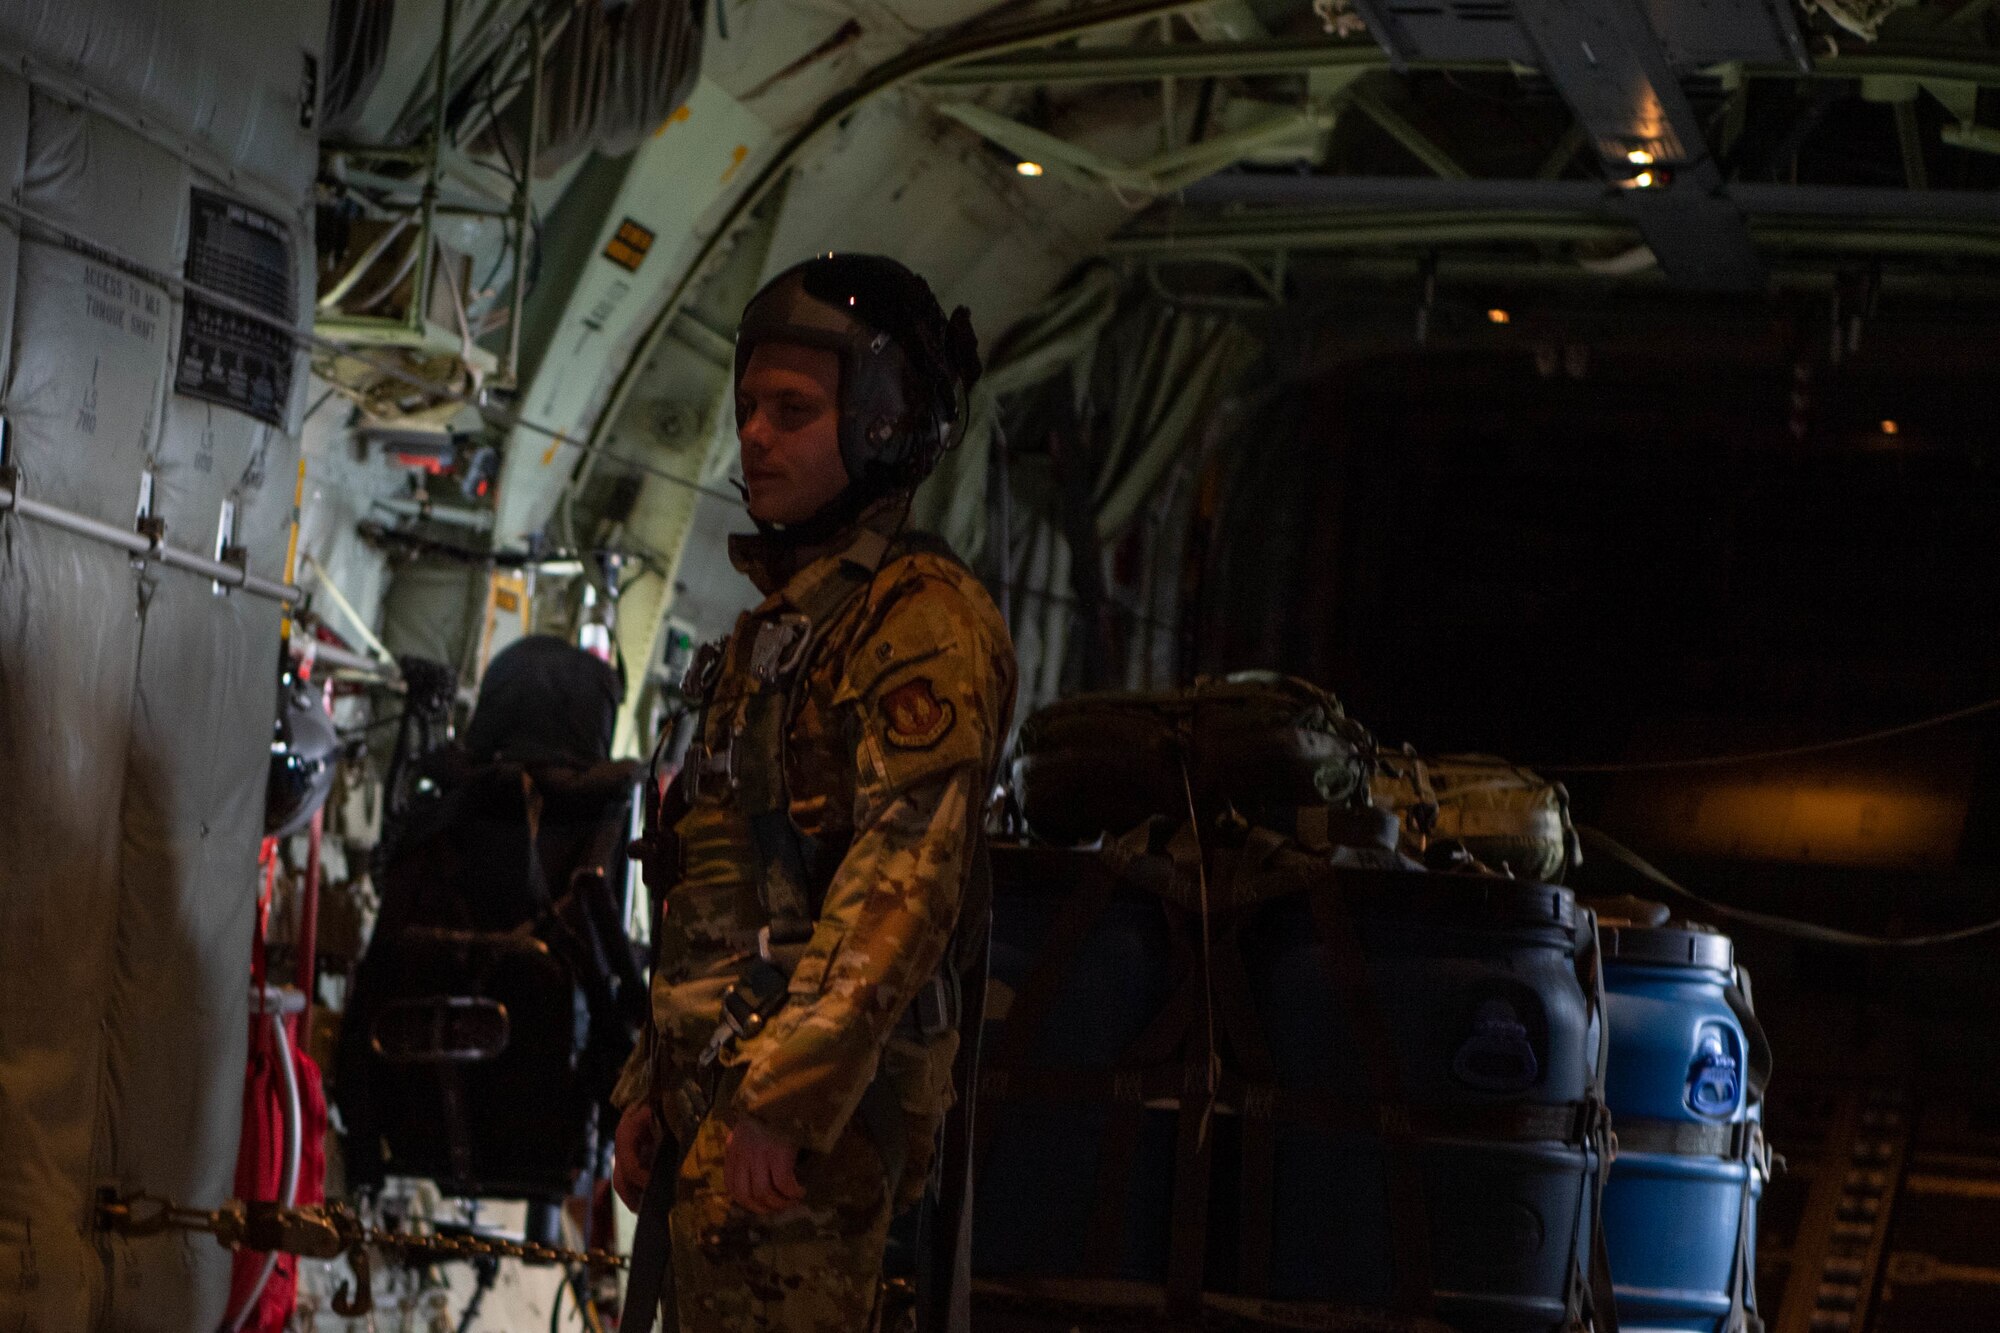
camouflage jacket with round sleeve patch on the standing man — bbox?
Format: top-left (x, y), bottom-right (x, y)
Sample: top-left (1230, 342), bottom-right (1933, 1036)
top-left (616, 500), bottom-right (1014, 1153)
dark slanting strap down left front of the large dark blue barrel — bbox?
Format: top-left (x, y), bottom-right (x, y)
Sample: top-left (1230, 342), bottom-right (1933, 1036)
top-left (1306, 881), bottom-right (1434, 1315)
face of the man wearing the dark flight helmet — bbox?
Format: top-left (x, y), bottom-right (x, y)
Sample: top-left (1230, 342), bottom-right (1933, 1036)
top-left (736, 342), bottom-right (848, 522)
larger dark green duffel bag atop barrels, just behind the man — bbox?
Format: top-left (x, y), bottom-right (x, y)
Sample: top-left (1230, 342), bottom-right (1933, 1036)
top-left (1012, 671), bottom-right (1374, 847)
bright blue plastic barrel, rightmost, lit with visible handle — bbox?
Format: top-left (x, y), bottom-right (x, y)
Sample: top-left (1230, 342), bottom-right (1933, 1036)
top-left (1602, 925), bottom-right (1764, 1333)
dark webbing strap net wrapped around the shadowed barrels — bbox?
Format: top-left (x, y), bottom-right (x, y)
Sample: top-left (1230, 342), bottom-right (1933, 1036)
top-left (978, 852), bottom-right (1616, 1333)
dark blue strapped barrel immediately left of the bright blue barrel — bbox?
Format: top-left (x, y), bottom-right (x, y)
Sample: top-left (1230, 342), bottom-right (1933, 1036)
top-left (1244, 873), bottom-right (1596, 1333)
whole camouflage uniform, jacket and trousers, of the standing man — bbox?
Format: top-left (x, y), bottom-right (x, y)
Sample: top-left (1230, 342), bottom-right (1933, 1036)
top-left (618, 500), bottom-right (1014, 1333)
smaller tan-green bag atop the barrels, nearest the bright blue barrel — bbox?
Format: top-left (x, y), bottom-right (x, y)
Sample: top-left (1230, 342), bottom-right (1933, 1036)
top-left (1370, 747), bottom-right (1582, 885)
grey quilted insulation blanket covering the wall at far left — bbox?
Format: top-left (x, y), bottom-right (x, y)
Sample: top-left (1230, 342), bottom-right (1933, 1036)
top-left (0, 2), bottom-right (324, 1333)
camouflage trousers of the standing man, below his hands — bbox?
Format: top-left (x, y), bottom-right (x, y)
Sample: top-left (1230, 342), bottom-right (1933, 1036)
top-left (672, 1119), bottom-right (890, 1333)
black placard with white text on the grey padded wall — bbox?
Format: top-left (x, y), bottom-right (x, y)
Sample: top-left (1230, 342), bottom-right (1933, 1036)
top-left (174, 190), bottom-right (296, 426)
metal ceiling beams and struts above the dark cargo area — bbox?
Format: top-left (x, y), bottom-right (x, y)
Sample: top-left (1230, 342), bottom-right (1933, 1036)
top-left (922, 23), bottom-right (2000, 290)
